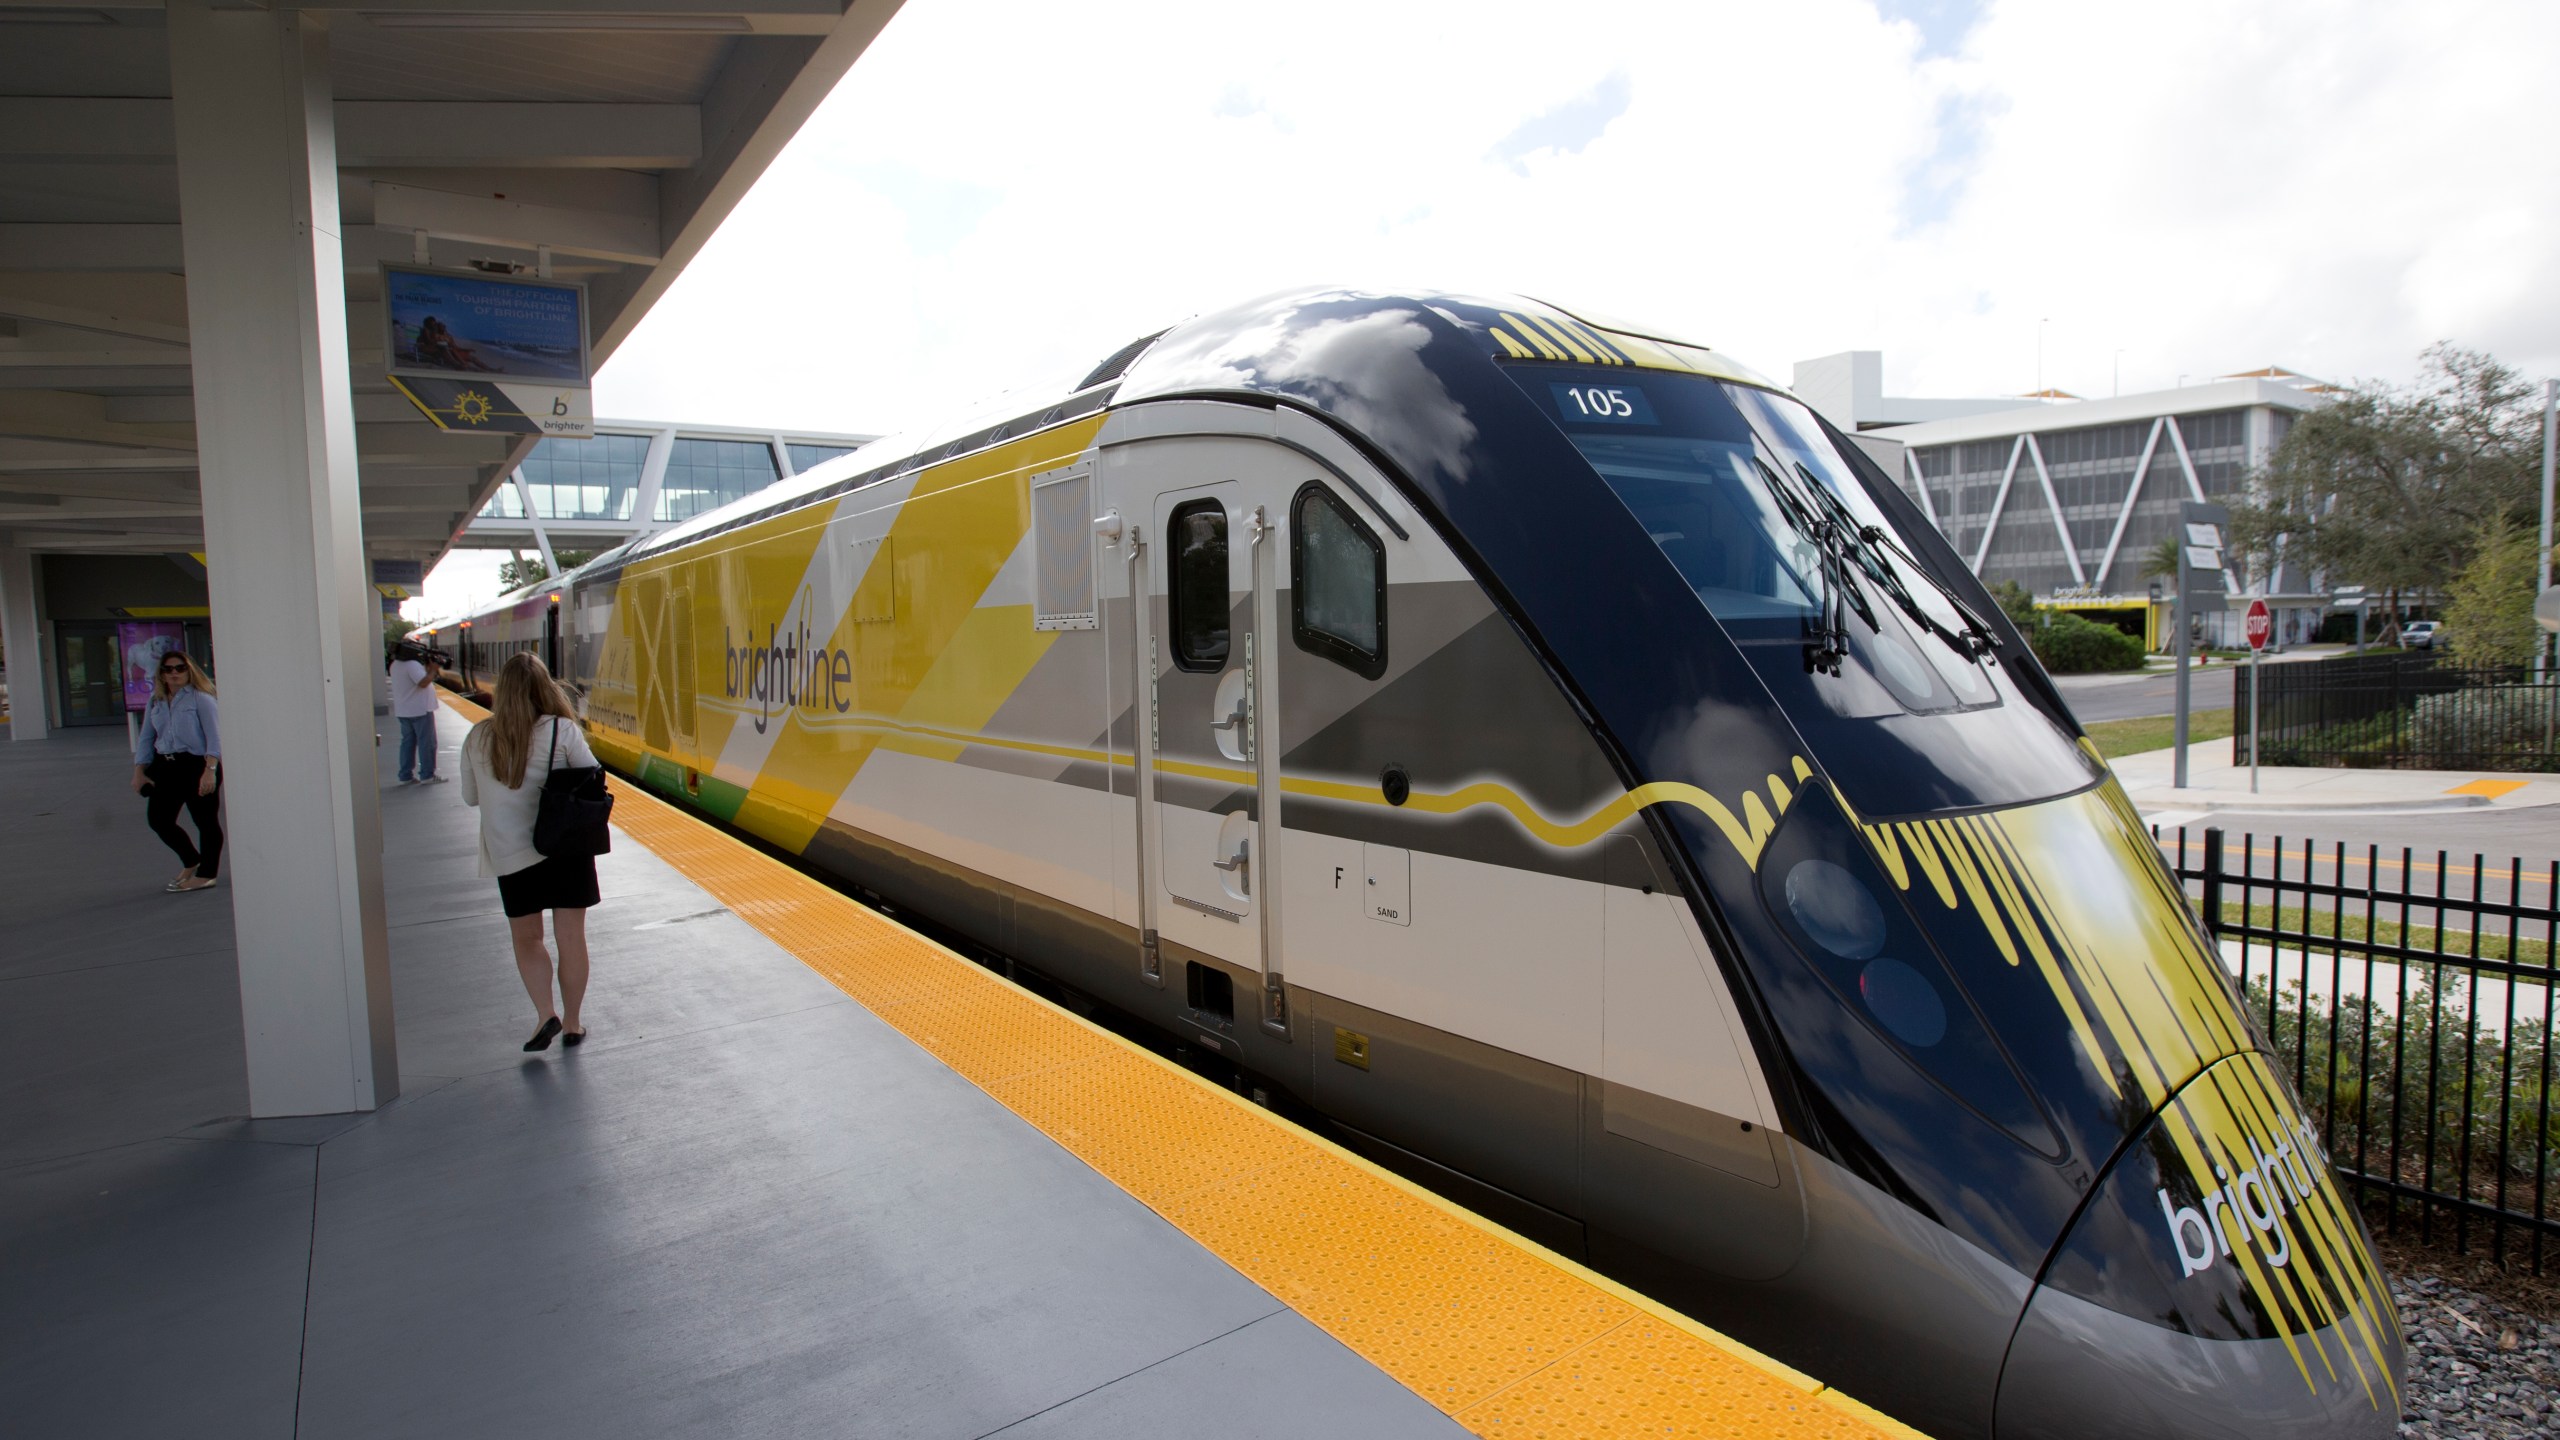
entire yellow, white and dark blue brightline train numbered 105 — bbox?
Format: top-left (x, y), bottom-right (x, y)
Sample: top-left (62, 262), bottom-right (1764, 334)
top-left (440, 290), bottom-right (2404, 1440)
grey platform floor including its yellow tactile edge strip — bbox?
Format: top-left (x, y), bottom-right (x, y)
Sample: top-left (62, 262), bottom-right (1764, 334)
top-left (0, 712), bottom-right (1912, 1437)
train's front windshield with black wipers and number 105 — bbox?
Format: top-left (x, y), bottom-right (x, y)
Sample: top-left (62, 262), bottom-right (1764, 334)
top-left (1513, 366), bottom-right (1999, 717)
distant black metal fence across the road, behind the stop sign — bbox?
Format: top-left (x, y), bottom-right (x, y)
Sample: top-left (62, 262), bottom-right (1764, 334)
top-left (2232, 653), bottom-right (2560, 771)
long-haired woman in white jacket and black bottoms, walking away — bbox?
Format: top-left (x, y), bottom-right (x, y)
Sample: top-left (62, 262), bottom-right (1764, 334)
top-left (463, 653), bottom-right (596, 1051)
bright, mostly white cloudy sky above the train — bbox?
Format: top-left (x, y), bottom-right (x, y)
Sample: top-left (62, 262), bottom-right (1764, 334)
top-left (414, 0), bottom-right (2560, 609)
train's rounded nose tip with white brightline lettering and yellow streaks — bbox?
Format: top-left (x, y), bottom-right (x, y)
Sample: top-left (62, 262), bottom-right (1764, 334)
top-left (1994, 1053), bottom-right (2406, 1440)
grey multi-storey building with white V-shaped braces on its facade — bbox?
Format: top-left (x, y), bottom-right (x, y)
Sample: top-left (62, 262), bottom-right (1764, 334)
top-left (1843, 361), bottom-right (2330, 643)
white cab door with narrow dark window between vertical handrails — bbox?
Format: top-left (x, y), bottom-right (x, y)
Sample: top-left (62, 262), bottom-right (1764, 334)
top-left (1114, 441), bottom-right (1288, 1035)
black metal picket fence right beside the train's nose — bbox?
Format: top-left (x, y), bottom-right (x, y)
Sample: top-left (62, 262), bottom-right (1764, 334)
top-left (2153, 828), bottom-right (2560, 1273)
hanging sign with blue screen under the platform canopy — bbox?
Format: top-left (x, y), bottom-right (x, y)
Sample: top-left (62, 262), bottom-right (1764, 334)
top-left (381, 264), bottom-right (596, 438)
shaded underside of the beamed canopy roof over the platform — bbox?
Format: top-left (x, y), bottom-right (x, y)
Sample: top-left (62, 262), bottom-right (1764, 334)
top-left (0, 0), bottom-right (901, 564)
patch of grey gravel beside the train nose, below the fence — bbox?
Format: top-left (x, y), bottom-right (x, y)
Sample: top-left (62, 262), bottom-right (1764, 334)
top-left (2391, 1276), bottom-right (2560, 1440)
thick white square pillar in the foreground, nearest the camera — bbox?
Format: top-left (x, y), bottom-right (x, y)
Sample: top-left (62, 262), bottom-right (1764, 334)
top-left (169, 0), bottom-right (399, 1115)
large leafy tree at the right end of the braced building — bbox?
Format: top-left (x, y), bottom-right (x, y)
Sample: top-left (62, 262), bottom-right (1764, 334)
top-left (2232, 343), bottom-right (2542, 638)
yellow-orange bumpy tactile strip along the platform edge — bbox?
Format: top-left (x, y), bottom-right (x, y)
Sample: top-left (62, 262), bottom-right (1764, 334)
top-left (448, 700), bottom-right (1917, 1440)
